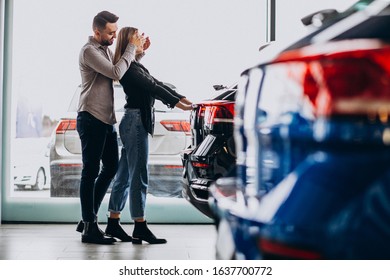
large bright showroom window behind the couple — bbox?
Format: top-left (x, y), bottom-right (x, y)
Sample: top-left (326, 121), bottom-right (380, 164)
top-left (1, 0), bottom-right (267, 222)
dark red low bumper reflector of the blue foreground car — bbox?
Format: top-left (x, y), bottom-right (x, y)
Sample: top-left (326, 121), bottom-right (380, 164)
top-left (258, 239), bottom-right (323, 260)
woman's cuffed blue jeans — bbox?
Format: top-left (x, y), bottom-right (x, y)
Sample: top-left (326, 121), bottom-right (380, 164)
top-left (108, 109), bottom-right (149, 220)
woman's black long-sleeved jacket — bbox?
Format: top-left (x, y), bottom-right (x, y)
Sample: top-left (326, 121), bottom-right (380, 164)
top-left (119, 61), bottom-right (184, 135)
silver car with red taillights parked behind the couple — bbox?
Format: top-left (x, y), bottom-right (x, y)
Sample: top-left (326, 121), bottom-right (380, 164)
top-left (50, 84), bottom-right (190, 197)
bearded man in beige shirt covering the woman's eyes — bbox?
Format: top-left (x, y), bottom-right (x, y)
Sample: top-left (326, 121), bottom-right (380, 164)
top-left (77, 11), bottom-right (145, 244)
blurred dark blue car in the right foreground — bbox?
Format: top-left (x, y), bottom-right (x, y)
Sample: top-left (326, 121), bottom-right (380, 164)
top-left (209, 0), bottom-right (390, 259)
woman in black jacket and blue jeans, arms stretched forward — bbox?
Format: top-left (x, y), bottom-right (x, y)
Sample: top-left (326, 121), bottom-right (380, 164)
top-left (106, 27), bottom-right (192, 244)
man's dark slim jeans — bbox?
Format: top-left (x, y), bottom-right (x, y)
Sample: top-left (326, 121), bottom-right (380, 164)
top-left (77, 112), bottom-right (119, 222)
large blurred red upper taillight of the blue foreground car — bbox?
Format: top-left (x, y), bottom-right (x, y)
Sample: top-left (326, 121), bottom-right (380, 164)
top-left (277, 40), bottom-right (390, 117)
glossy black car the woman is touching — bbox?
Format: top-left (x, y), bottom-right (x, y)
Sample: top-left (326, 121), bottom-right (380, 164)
top-left (182, 85), bottom-right (237, 218)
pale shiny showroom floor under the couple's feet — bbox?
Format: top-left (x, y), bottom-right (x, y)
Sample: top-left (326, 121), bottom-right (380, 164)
top-left (0, 224), bottom-right (216, 260)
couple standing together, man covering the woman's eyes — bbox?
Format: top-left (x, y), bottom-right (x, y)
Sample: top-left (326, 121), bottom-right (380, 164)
top-left (77, 11), bottom-right (192, 244)
